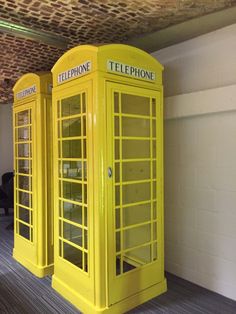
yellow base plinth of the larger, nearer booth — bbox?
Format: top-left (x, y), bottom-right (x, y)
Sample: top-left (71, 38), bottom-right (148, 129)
top-left (52, 275), bottom-right (167, 314)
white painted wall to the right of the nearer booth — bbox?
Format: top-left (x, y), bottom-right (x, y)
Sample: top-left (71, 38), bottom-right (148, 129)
top-left (153, 25), bottom-right (236, 300)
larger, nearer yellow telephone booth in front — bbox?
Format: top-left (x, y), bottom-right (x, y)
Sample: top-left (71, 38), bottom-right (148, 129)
top-left (52, 44), bottom-right (166, 314)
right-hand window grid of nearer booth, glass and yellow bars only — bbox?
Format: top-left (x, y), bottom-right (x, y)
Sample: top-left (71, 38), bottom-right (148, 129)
top-left (113, 92), bottom-right (157, 275)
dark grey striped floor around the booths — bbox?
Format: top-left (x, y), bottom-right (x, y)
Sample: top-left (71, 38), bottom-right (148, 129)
top-left (0, 217), bottom-right (236, 314)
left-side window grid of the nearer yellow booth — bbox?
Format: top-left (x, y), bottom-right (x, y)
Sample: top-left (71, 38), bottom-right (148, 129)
top-left (57, 93), bottom-right (88, 272)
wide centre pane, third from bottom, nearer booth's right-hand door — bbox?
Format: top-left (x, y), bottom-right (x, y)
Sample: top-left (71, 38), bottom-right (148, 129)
top-left (123, 204), bottom-right (151, 227)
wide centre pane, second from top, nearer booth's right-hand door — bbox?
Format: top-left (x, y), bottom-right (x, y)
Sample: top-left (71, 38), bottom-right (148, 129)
top-left (122, 117), bottom-right (150, 137)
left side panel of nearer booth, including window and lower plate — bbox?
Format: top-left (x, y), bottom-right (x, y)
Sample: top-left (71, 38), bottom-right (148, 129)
top-left (54, 80), bottom-right (94, 299)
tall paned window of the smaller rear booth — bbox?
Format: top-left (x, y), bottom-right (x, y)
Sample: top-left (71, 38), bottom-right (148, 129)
top-left (14, 102), bottom-right (35, 245)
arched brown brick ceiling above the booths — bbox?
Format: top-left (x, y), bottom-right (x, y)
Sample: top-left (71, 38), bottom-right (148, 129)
top-left (0, 0), bottom-right (236, 103)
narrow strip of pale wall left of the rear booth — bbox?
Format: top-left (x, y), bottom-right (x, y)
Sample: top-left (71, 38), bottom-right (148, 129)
top-left (0, 104), bottom-right (13, 181)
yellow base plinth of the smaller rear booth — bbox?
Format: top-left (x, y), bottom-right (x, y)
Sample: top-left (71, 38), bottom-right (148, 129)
top-left (13, 249), bottom-right (53, 278)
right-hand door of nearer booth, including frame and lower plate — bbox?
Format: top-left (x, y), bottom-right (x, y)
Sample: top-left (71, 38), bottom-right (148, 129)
top-left (107, 83), bottom-right (162, 303)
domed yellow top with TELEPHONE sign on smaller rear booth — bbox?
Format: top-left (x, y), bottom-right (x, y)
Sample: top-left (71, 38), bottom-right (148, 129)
top-left (13, 72), bottom-right (52, 103)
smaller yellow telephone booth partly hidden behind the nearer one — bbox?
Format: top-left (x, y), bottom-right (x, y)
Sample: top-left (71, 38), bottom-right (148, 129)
top-left (13, 73), bottom-right (53, 277)
